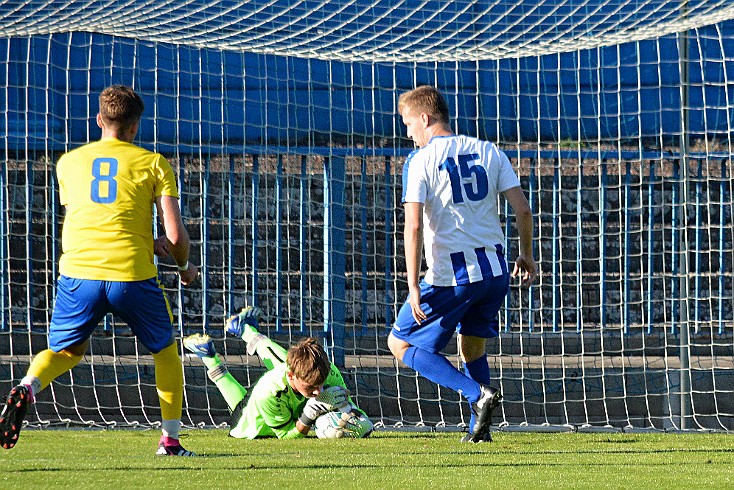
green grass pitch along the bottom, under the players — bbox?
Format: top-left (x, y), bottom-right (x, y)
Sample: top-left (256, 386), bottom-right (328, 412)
top-left (0, 428), bottom-right (734, 490)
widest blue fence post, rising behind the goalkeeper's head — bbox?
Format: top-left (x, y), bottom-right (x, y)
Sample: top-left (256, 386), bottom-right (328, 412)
top-left (324, 156), bottom-right (346, 367)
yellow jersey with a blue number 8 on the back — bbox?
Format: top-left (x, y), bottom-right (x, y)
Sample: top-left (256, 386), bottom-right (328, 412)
top-left (56, 138), bottom-right (178, 282)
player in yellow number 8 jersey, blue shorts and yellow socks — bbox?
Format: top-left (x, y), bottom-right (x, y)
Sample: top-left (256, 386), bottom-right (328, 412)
top-left (0, 85), bottom-right (199, 456)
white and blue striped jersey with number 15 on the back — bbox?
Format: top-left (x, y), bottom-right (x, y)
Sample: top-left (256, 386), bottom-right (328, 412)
top-left (403, 135), bottom-right (520, 286)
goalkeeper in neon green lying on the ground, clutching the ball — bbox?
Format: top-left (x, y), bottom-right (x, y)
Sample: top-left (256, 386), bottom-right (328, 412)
top-left (183, 306), bottom-right (373, 439)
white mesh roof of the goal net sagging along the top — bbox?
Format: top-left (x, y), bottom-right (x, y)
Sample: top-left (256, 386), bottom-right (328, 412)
top-left (0, 0), bottom-right (734, 62)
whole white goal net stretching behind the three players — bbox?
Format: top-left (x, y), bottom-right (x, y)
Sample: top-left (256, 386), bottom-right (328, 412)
top-left (0, 0), bottom-right (734, 431)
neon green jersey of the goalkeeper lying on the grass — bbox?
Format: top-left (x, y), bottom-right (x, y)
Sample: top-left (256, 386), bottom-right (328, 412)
top-left (229, 364), bottom-right (347, 439)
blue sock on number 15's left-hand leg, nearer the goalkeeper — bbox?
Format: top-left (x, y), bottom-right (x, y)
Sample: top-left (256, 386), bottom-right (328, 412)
top-left (403, 346), bottom-right (481, 403)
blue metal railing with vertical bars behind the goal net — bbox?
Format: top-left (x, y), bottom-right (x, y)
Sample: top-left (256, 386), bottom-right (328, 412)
top-left (0, 146), bottom-right (732, 340)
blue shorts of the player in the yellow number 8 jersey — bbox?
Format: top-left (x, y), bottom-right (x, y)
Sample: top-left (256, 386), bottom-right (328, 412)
top-left (48, 276), bottom-right (174, 354)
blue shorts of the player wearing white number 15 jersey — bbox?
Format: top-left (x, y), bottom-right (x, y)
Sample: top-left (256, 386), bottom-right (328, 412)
top-left (392, 274), bottom-right (510, 352)
